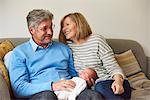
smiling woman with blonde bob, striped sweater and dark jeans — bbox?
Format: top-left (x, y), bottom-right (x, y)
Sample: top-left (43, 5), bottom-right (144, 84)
top-left (59, 13), bottom-right (131, 100)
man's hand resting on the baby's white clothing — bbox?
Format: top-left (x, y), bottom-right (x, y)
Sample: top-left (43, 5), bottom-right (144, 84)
top-left (52, 80), bottom-right (76, 91)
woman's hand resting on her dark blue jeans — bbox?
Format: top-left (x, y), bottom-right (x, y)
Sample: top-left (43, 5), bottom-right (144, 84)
top-left (111, 74), bottom-right (124, 94)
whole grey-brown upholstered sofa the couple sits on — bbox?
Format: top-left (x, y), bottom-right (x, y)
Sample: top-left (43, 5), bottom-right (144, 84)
top-left (0, 38), bottom-right (150, 100)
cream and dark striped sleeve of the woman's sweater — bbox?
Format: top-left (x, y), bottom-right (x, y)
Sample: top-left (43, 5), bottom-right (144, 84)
top-left (98, 36), bottom-right (125, 79)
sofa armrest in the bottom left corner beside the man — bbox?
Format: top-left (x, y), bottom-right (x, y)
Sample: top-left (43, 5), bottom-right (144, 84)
top-left (0, 73), bottom-right (10, 100)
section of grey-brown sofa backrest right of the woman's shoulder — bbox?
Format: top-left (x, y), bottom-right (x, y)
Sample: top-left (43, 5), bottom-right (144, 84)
top-left (107, 39), bottom-right (148, 74)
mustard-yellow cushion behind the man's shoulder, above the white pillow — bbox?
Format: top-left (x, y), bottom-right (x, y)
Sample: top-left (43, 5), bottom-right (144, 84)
top-left (0, 40), bottom-right (14, 60)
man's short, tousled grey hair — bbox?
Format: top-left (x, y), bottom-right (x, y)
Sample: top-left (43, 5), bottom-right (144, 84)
top-left (26, 9), bottom-right (53, 28)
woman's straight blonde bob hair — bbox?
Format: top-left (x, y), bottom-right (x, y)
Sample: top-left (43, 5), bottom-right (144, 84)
top-left (59, 12), bottom-right (92, 44)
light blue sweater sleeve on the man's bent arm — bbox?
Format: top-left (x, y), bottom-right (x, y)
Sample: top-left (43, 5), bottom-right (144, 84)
top-left (8, 51), bottom-right (52, 98)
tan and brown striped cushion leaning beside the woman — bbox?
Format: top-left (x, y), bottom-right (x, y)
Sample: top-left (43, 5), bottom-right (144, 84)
top-left (115, 50), bottom-right (150, 89)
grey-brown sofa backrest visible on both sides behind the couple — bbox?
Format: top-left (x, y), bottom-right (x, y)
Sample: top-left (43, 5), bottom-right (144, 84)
top-left (0, 38), bottom-right (147, 74)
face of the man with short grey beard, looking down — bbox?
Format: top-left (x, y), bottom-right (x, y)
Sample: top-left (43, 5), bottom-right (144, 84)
top-left (29, 20), bottom-right (53, 46)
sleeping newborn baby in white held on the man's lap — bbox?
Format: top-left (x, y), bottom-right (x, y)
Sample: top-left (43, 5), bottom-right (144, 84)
top-left (55, 68), bottom-right (98, 100)
